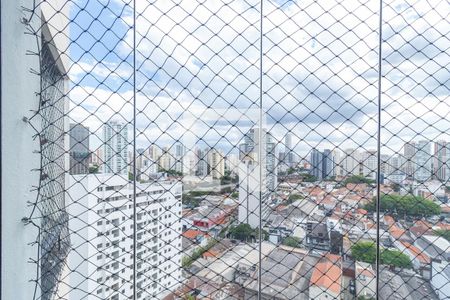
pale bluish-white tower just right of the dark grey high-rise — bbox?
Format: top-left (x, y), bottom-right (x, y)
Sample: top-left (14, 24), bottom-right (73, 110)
top-left (102, 121), bottom-right (128, 175)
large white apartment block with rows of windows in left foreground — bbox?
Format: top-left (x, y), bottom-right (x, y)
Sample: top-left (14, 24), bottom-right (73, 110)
top-left (67, 174), bottom-right (182, 300)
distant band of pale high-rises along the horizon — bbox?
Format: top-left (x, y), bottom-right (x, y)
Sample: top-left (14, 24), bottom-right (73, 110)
top-left (78, 123), bottom-right (450, 184)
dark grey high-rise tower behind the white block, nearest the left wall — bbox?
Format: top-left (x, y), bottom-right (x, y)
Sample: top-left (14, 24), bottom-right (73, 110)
top-left (69, 124), bottom-right (91, 175)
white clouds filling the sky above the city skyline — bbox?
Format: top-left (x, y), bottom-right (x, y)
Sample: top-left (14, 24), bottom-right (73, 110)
top-left (67, 0), bottom-right (450, 154)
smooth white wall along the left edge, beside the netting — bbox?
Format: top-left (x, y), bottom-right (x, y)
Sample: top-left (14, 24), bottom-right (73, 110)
top-left (1, 0), bottom-right (40, 300)
